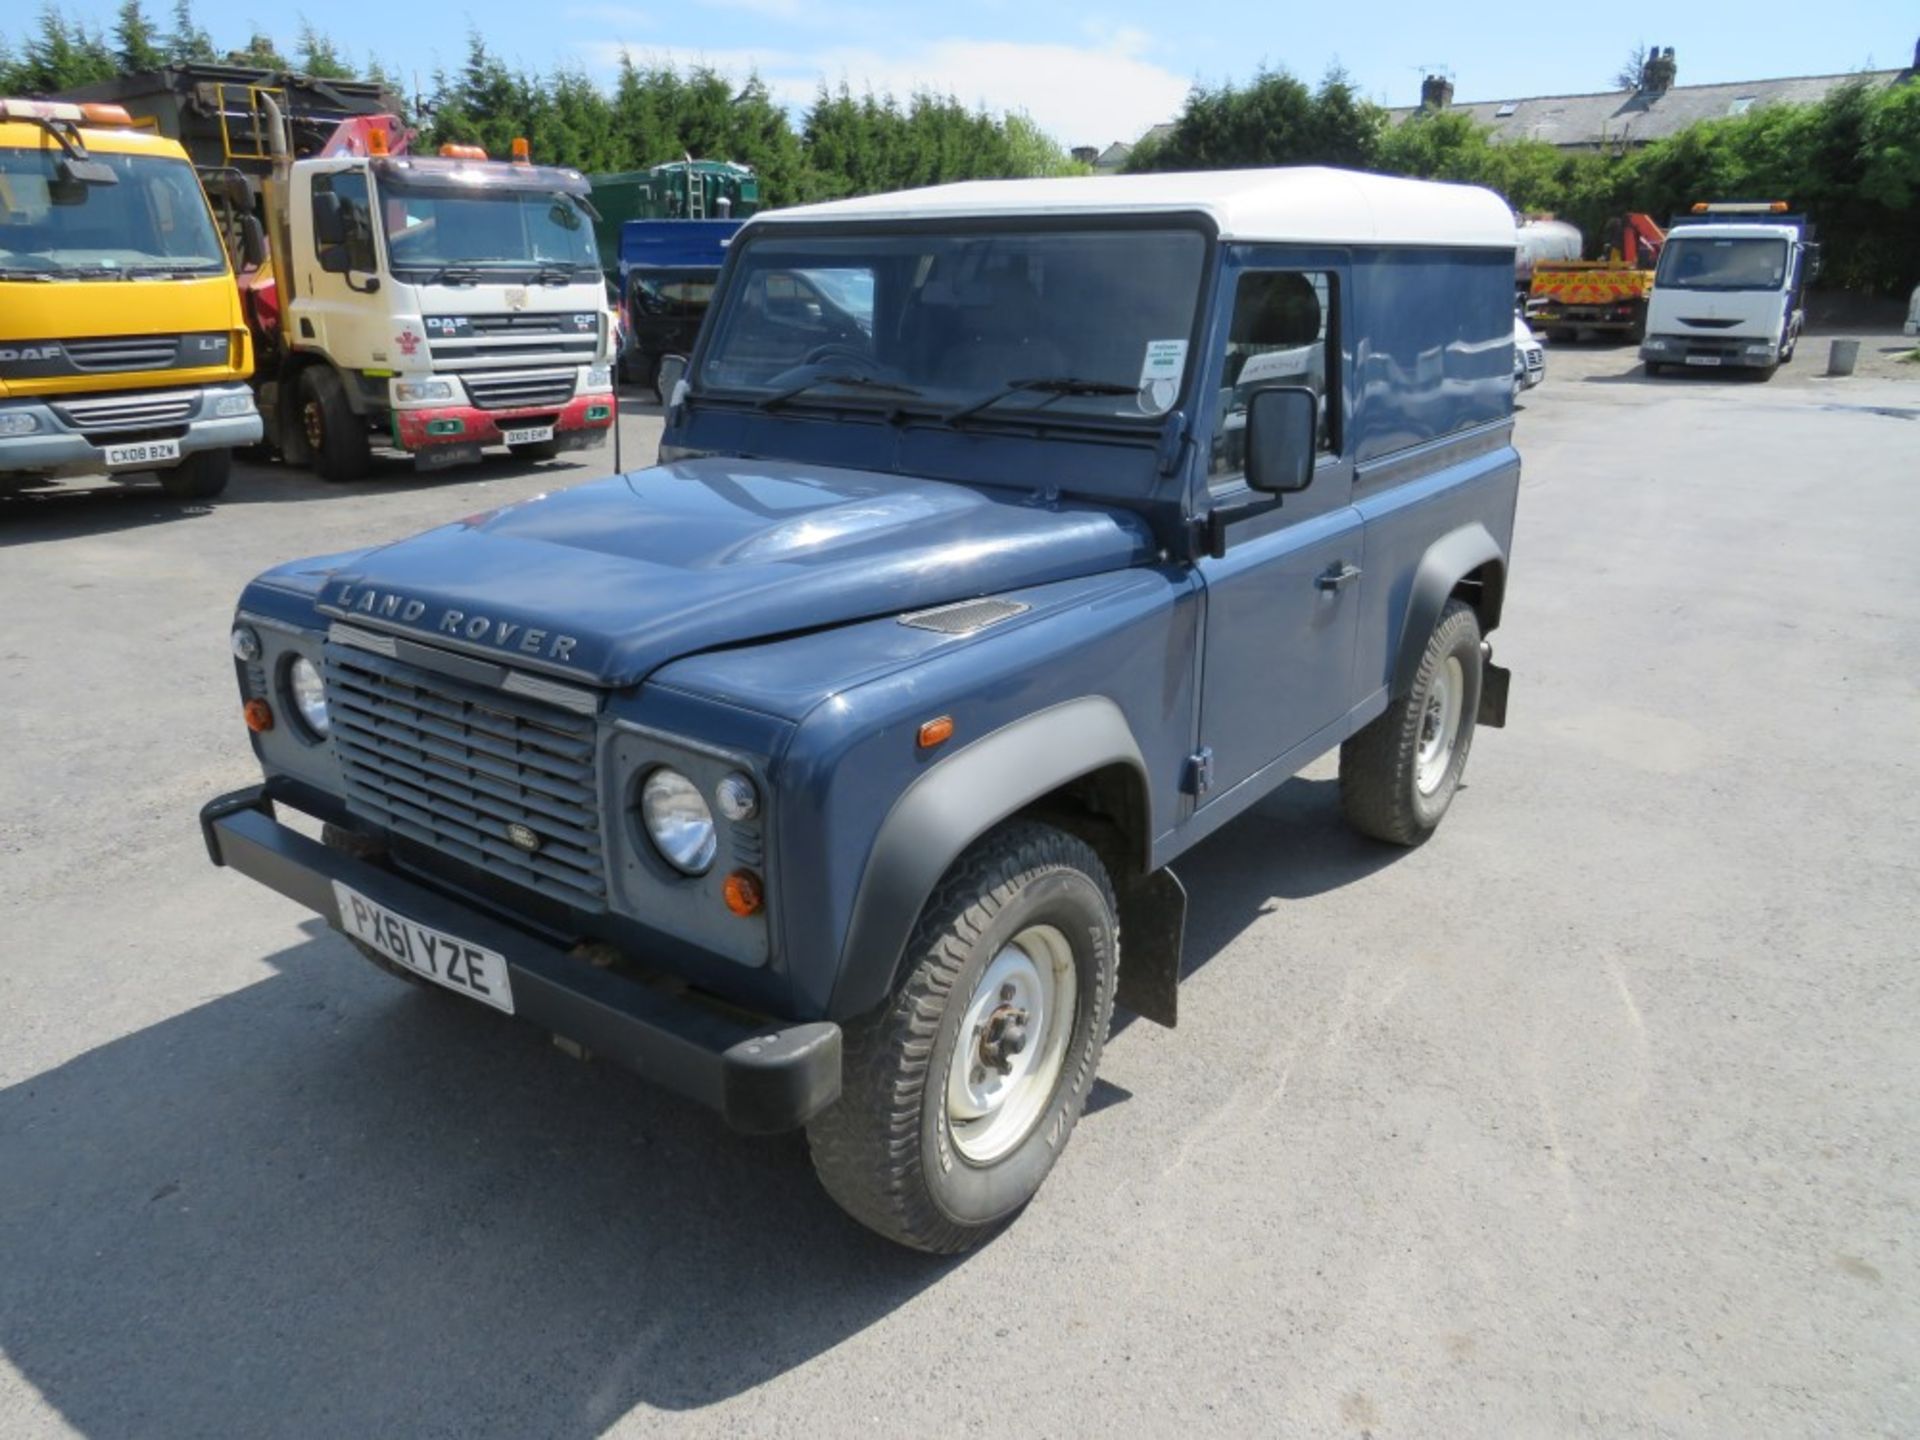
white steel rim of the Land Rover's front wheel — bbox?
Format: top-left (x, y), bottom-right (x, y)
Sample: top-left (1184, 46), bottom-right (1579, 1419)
top-left (947, 925), bottom-right (1079, 1165)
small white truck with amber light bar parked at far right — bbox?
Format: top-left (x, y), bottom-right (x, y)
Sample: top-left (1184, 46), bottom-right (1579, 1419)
top-left (1640, 202), bottom-right (1820, 380)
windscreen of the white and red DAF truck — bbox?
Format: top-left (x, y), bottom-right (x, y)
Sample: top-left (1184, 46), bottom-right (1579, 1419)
top-left (380, 175), bottom-right (599, 280)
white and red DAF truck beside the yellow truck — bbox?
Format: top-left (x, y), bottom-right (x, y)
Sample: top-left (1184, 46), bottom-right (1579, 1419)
top-left (248, 109), bottom-right (614, 480)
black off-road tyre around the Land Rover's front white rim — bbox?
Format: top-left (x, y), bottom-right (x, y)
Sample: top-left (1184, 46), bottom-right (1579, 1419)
top-left (806, 820), bottom-right (1119, 1254)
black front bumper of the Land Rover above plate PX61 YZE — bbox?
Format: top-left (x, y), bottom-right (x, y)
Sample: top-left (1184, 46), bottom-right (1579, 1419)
top-left (200, 785), bottom-right (841, 1135)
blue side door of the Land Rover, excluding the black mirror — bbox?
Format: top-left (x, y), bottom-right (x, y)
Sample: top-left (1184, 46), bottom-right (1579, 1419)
top-left (1198, 261), bottom-right (1363, 808)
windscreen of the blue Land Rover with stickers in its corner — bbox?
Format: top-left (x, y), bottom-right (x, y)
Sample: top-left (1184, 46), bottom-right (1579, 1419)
top-left (695, 228), bottom-right (1206, 420)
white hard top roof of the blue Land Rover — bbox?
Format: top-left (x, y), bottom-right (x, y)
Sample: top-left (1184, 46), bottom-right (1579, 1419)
top-left (747, 165), bottom-right (1515, 250)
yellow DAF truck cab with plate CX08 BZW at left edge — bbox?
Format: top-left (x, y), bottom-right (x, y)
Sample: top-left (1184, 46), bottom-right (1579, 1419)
top-left (0, 100), bottom-right (261, 499)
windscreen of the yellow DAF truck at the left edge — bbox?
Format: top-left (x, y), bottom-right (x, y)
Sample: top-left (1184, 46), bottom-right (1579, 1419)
top-left (0, 146), bottom-right (227, 280)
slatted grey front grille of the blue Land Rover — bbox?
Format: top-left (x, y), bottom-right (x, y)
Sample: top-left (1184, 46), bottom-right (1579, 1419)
top-left (326, 643), bottom-right (607, 910)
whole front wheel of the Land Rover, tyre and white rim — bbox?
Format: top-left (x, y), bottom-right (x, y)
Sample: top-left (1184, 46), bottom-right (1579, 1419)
top-left (806, 820), bottom-right (1119, 1254)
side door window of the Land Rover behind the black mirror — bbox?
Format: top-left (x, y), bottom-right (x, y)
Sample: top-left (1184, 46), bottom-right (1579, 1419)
top-left (1208, 271), bottom-right (1340, 488)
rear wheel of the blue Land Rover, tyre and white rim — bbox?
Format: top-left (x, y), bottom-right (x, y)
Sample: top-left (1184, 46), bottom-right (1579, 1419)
top-left (1340, 601), bottom-right (1480, 845)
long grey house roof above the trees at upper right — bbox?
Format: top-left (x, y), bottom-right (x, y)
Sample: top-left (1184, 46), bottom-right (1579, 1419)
top-left (1388, 69), bottom-right (1912, 146)
